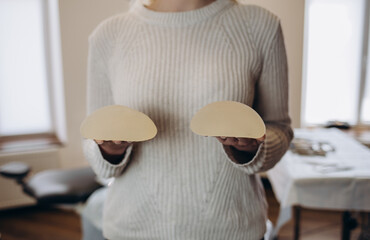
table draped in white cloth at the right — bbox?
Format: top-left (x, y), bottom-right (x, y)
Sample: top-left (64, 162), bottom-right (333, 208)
top-left (267, 129), bottom-right (370, 239)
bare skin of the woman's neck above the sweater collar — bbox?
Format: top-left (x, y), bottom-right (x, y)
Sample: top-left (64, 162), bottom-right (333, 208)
top-left (146, 0), bottom-right (215, 12)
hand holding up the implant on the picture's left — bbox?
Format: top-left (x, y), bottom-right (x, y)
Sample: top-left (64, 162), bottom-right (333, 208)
top-left (94, 139), bottom-right (132, 164)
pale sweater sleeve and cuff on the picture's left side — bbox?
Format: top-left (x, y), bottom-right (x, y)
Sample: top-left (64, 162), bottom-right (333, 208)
top-left (82, 21), bottom-right (132, 178)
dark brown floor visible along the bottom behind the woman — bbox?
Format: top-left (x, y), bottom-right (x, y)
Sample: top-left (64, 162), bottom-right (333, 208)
top-left (0, 180), bottom-right (366, 240)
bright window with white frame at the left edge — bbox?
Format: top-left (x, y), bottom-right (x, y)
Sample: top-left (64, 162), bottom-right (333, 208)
top-left (0, 0), bottom-right (65, 149)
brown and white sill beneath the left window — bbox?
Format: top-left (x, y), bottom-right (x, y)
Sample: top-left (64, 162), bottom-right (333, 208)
top-left (0, 133), bottom-right (63, 154)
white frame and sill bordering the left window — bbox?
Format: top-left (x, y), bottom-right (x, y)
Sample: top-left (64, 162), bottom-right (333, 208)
top-left (0, 0), bottom-right (67, 154)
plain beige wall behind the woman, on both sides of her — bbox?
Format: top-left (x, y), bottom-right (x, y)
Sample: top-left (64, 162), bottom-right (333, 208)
top-left (60, 0), bottom-right (304, 168)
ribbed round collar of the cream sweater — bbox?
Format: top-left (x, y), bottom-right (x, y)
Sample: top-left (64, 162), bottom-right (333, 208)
top-left (130, 0), bottom-right (234, 26)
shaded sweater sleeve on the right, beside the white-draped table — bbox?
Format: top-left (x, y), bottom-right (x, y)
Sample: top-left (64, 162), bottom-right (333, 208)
top-left (224, 22), bottom-right (293, 174)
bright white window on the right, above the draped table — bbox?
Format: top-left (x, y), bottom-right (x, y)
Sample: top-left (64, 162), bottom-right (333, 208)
top-left (302, 0), bottom-right (370, 126)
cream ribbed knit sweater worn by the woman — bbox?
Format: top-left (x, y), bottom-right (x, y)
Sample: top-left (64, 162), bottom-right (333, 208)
top-left (83, 0), bottom-right (293, 240)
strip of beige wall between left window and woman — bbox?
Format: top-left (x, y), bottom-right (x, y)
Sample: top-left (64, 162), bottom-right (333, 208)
top-left (59, 0), bottom-right (128, 168)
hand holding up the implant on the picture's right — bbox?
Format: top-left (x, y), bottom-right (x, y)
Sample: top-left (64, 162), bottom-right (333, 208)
top-left (216, 135), bottom-right (266, 153)
